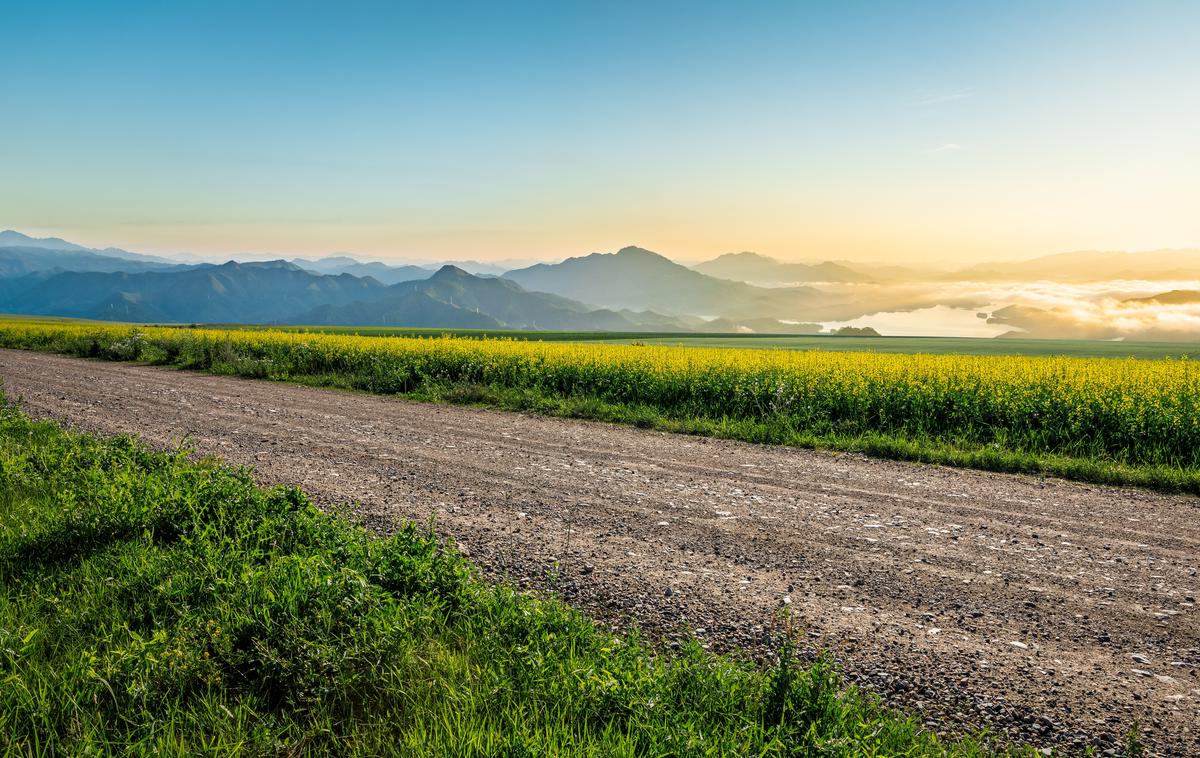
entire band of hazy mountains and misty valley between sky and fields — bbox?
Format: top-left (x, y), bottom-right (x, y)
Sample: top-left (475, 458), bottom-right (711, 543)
top-left (0, 230), bottom-right (1200, 341)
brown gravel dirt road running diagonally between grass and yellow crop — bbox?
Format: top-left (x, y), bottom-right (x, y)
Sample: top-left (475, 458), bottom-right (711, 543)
top-left (0, 350), bottom-right (1200, 756)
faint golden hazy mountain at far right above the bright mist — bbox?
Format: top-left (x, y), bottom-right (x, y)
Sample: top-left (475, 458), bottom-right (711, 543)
top-left (943, 249), bottom-right (1200, 282)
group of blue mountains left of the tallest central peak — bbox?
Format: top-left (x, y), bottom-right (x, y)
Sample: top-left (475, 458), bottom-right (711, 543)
top-left (0, 233), bottom-right (701, 331)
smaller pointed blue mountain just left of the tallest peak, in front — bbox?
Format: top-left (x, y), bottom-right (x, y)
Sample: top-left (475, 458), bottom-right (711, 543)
top-left (287, 265), bottom-right (683, 331)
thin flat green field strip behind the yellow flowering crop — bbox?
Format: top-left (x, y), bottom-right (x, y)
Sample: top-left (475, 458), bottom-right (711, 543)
top-left (226, 326), bottom-right (1200, 359)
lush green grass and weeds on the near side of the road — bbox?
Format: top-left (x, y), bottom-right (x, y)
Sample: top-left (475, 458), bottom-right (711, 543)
top-left (0, 407), bottom-right (1022, 756)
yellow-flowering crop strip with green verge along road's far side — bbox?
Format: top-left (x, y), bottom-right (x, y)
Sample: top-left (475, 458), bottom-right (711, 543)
top-left (0, 321), bottom-right (1200, 493)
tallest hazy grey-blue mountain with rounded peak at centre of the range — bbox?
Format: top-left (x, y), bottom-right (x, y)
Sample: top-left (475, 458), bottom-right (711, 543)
top-left (504, 247), bottom-right (824, 320)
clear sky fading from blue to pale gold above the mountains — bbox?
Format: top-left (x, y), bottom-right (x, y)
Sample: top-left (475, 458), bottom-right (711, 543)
top-left (0, 0), bottom-right (1200, 261)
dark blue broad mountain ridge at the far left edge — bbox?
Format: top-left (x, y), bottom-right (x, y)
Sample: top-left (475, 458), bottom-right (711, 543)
top-left (0, 260), bottom-right (385, 324)
